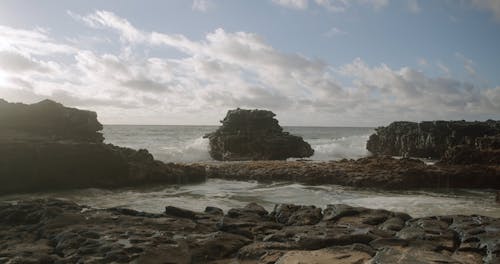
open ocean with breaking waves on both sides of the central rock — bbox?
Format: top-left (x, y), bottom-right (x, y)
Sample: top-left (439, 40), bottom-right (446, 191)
top-left (103, 125), bottom-right (374, 162)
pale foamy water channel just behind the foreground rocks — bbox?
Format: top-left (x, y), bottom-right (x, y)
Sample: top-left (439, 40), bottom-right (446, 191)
top-left (0, 179), bottom-right (500, 217)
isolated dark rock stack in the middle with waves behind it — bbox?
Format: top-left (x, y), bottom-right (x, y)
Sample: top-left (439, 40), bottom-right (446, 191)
top-left (205, 108), bottom-right (314, 161)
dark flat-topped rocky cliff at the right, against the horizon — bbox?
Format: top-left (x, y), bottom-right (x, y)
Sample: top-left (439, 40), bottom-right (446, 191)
top-left (366, 120), bottom-right (500, 159)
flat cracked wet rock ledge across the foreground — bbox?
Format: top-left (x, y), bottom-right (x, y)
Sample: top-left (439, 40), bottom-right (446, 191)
top-left (0, 200), bottom-right (500, 264)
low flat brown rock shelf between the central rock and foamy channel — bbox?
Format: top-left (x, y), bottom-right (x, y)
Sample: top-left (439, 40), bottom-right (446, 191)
top-left (205, 156), bottom-right (500, 189)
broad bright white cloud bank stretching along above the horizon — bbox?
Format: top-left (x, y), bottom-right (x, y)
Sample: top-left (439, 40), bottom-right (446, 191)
top-left (0, 11), bottom-right (500, 126)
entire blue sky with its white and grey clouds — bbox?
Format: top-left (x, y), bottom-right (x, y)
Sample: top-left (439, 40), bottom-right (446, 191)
top-left (0, 0), bottom-right (500, 127)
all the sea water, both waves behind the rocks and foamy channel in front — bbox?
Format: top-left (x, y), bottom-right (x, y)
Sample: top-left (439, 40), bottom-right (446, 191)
top-left (0, 126), bottom-right (500, 217)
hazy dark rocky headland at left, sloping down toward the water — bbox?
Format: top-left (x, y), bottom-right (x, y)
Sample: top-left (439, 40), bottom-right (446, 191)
top-left (0, 100), bottom-right (205, 194)
